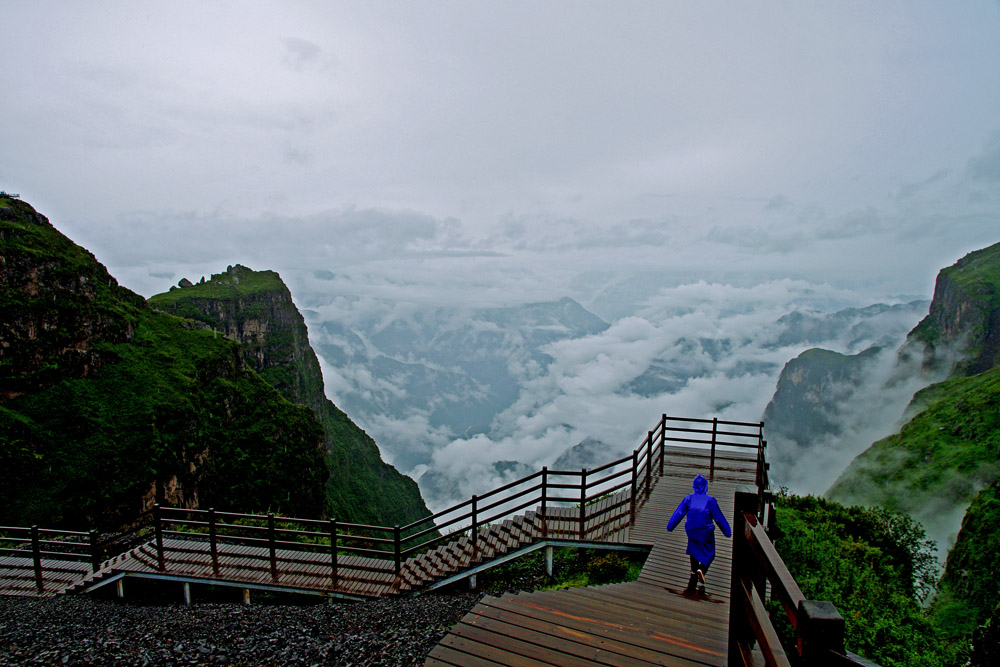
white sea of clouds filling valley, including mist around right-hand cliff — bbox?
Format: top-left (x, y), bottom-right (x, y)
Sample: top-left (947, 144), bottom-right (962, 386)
top-left (298, 271), bottom-right (926, 509)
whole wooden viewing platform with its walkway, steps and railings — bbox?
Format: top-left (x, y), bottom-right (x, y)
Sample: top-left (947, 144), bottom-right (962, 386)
top-left (0, 415), bottom-right (871, 667)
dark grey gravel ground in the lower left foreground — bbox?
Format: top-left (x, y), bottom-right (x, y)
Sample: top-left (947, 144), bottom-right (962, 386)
top-left (0, 592), bottom-right (482, 666)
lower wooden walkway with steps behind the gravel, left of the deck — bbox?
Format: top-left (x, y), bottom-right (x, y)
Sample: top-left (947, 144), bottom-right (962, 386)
top-left (0, 491), bottom-right (630, 600)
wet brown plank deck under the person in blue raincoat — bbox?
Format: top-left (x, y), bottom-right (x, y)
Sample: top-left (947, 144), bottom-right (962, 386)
top-left (424, 450), bottom-right (756, 667)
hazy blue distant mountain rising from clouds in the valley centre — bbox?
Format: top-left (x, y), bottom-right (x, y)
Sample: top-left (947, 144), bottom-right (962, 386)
top-left (316, 298), bottom-right (608, 468)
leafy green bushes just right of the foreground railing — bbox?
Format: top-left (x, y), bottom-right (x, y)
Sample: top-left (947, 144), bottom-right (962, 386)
top-left (773, 494), bottom-right (964, 667)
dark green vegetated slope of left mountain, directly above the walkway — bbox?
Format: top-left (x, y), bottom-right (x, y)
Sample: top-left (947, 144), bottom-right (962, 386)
top-left (0, 306), bottom-right (326, 526)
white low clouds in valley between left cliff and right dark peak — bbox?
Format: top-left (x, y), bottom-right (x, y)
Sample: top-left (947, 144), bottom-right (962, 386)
top-left (298, 274), bottom-right (917, 508)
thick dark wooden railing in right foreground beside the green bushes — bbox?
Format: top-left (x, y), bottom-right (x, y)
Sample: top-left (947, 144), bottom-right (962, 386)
top-left (729, 488), bottom-right (877, 667)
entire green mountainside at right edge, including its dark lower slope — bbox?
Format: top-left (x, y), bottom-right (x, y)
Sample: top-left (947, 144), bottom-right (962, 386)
top-left (827, 244), bottom-right (1000, 665)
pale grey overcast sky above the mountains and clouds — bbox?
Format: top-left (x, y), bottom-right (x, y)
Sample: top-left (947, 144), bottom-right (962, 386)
top-left (0, 0), bottom-right (1000, 300)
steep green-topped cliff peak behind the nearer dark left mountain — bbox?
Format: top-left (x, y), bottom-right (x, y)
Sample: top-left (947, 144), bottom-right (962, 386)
top-left (150, 265), bottom-right (430, 525)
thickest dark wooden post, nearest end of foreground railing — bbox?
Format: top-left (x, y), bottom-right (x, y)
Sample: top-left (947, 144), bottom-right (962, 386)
top-left (729, 486), bottom-right (757, 665)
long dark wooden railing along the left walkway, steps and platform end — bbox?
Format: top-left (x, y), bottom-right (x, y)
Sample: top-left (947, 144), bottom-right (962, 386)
top-left (7, 414), bottom-right (767, 591)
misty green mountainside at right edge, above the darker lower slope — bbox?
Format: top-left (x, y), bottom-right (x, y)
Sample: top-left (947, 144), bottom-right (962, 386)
top-left (830, 243), bottom-right (1000, 520)
